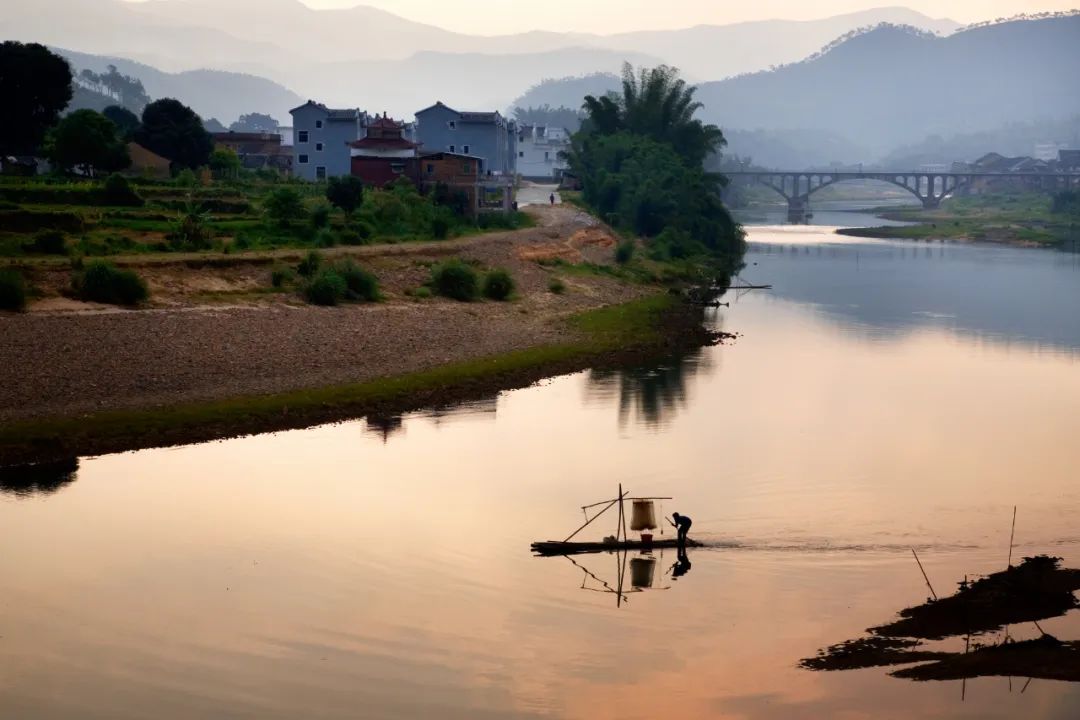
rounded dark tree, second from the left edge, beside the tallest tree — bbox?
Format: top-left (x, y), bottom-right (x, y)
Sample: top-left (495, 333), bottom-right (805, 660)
top-left (45, 110), bottom-right (131, 177)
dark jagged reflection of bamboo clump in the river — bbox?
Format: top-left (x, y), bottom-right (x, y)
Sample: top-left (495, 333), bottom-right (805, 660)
top-left (586, 350), bottom-right (712, 427)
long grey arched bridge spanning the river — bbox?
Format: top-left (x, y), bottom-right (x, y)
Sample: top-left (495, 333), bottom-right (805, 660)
top-left (725, 171), bottom-right (1080, 222)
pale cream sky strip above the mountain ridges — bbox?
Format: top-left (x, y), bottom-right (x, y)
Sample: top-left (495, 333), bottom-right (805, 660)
top-left (301, 0), bottom-right (1080, 35)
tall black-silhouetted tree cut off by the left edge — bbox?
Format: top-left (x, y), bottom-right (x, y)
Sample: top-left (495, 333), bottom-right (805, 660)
top-left (0, 40), bottom-right (71, 155)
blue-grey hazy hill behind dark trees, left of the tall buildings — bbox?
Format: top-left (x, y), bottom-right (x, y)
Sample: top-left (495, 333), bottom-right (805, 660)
top-left (53, 47), bottom-right (303, 124)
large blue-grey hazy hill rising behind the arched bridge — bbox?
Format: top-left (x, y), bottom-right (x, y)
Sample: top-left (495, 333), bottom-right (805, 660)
top-left (698, 16), bottom-right (1080, 160)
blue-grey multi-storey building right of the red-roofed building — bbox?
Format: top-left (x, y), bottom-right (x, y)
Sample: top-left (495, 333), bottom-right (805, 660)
top-left (415, 103), bottom-right (517, 176)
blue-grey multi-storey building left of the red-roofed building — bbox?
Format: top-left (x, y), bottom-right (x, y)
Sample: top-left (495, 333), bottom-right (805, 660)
top-left (289, 100), bottom-right (367, 180)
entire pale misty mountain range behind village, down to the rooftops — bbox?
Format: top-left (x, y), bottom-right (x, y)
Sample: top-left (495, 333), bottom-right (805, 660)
top-left (0, 0), bottom-right (957, 117)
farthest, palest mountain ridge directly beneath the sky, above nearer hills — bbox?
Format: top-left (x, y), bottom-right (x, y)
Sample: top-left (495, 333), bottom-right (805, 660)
top-left (6, 0), bottom-right (956, 80)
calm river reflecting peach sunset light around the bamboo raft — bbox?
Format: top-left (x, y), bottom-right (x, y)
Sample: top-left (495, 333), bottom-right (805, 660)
top-left (0, 213), bottom-right (1080, 720)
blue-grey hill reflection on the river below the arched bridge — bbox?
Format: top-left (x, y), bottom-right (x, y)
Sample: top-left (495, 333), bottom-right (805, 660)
top-left (747, 228), bottom-right (1080, 354)
